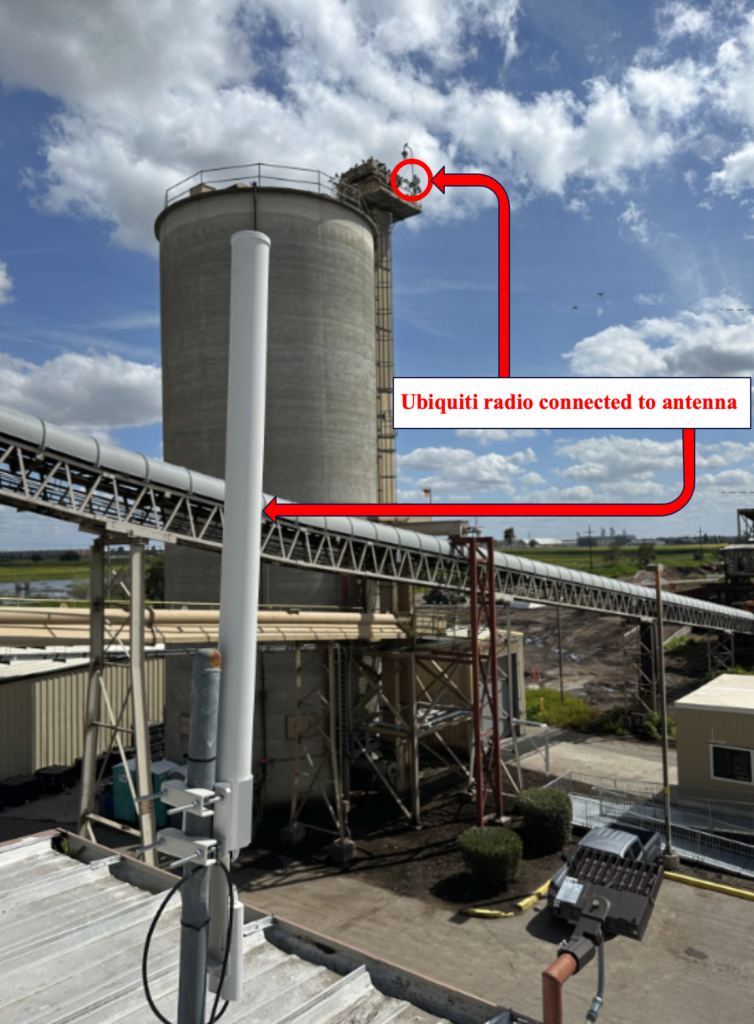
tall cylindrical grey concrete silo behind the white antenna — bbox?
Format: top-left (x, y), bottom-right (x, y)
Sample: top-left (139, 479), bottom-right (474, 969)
top-left (155, 161), bottom-right (419, 794)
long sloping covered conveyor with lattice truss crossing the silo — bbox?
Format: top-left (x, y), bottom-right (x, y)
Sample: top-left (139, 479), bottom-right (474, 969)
top-left (0, 407), bottom-right (754, 634)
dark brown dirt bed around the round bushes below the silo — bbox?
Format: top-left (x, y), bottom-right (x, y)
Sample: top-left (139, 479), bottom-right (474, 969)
top-left (238, 770), bottom-right (754, 911)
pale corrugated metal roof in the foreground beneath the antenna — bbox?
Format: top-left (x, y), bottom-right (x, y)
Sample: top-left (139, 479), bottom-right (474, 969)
top-left (0, 836), bottom-right (534, 1024)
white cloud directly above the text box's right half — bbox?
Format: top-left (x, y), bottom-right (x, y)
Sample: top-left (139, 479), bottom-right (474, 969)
top-left (563, 295), bottom-right (754, 377)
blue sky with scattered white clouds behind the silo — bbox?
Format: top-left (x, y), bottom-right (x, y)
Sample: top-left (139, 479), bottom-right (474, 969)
top-left (0, 0), bottom-right (754, 549)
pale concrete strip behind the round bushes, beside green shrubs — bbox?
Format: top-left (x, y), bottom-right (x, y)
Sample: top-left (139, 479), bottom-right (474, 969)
top-left (506, 729), bottom-right (678, 784)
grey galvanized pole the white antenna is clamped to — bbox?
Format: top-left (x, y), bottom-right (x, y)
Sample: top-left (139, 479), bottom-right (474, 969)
top-left (178, 649), bottom-right (220, 1024)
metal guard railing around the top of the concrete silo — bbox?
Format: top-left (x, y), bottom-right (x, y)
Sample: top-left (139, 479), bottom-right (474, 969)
top-left (165, 164), bottom-right (366, 213)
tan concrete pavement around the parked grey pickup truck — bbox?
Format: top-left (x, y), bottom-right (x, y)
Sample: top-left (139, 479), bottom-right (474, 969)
top-left (237, 862), bottom-right (754, 1024)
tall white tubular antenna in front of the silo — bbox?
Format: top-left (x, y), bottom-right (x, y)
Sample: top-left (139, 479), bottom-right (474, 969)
top-left (216, 231), bottom-right (270, 856)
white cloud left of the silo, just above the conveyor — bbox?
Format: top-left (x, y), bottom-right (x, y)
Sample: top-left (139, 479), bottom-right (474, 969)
top-left (0, 352), bottom-right (162, 438)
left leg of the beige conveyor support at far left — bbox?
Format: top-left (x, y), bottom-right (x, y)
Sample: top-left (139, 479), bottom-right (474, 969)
top-left (78, 537), bottom-right (104, 840)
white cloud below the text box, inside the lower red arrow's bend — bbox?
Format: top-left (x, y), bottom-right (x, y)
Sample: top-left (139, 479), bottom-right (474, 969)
top-left (555, 436), bottom-right (681, 489)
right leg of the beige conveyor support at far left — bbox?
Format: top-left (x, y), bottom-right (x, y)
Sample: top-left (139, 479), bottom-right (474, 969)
top-left (129, 544), bottom-right (158, 866)
